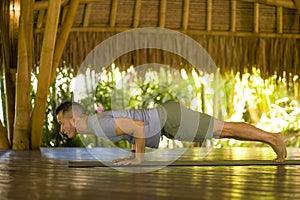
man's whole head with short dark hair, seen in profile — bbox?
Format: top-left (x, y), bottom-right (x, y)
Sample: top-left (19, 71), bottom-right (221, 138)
top-left (55, 101), bottom-right (86, 138)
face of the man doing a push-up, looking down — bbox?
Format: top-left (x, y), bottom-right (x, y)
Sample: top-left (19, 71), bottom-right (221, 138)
top-left (57, 112), bottom-right (77, 138)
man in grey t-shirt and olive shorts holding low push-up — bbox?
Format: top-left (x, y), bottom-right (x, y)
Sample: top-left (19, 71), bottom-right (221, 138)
top-left (56, 102), bottom-right (287, 165)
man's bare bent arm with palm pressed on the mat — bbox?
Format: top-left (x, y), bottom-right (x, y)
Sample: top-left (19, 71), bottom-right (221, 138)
top-left (115, 118), bottom-right (146, 165)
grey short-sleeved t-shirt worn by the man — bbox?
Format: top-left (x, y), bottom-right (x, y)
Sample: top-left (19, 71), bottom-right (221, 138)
top-left (88, 108), bottom-right (161, 148)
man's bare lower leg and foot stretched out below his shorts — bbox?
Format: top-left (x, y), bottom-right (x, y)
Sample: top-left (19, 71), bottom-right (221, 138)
top-left (213, 120), bottom-right (287, 162)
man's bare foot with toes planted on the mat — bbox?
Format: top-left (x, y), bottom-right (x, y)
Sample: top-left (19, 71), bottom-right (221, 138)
top-left (271, 133), bottom-right (287, 162)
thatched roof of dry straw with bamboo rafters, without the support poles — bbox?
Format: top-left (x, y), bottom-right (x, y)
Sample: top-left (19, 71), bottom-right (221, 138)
top-left (8, 0), bottom-right (300, 76)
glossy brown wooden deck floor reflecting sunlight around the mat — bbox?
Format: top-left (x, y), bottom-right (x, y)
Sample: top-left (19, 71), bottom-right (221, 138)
top-left (0, 148), bottom-right (300, 200)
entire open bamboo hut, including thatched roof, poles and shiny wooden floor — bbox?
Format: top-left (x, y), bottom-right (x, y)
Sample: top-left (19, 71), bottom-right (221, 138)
top-left (0, 0), bottom-right (300, 200)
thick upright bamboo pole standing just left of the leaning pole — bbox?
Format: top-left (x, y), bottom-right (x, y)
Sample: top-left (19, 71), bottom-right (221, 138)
top-left (12, 0), bottom-right (34, 149)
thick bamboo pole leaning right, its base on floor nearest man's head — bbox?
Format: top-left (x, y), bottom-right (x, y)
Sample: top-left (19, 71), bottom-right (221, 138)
top-left (31, 0), bottom-right (61, 149)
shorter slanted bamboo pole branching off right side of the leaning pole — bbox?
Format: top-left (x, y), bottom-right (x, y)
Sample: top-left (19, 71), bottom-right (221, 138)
top-left (49, 0), bottom-right (80, 86)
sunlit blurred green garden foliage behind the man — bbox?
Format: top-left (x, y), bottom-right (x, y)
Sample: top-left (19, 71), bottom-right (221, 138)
top-left (20, 64), bottom-right (300, 148)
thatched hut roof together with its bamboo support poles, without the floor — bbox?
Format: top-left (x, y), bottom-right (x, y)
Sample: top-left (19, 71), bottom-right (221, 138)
top-left (0, 0), bottom-right (300, 149)
